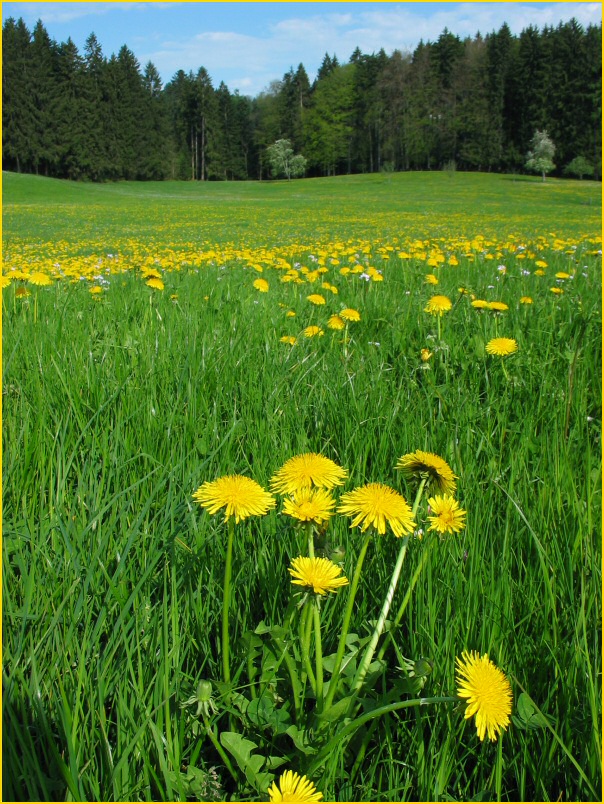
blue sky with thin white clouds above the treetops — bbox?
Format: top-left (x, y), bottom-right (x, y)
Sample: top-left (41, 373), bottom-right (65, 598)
top-left (2, 2), bottom-right (602, 96)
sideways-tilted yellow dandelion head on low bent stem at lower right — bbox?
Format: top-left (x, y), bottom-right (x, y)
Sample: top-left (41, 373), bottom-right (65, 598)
top-left (456, 651), bottom-right (512, 741)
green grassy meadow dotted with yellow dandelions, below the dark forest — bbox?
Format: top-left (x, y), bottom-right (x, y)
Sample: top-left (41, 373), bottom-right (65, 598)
top-left (2, 172), bottom-right (602, 802)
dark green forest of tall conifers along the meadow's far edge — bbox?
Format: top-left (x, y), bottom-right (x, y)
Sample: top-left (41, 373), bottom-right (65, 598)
top-left (2, 18), bottom-right (602, 181)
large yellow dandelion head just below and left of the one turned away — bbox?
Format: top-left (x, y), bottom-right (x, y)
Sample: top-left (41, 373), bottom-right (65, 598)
top-left (338, 483), bottom-right (415, 536)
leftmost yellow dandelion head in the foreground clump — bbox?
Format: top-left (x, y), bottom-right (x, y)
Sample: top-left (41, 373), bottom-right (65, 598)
top-left (193, 475), bottom-right (276, 523)
